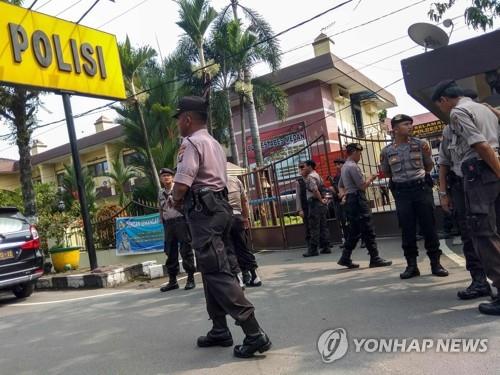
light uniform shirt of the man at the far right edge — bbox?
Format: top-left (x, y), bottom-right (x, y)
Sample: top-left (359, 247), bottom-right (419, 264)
top-left (450, 98), bottom-right (499, 161)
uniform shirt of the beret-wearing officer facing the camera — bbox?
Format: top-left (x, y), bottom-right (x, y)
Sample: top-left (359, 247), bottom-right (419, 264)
top-left (380, 137), bottom-right (434, 182)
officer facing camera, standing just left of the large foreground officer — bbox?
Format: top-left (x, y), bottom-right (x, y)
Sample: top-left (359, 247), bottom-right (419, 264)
top-left (158, 168), bottom-right (196, 292)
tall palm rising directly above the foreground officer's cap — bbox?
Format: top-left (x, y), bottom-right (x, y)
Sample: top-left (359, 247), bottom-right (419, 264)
top-left (176, 0), bottom-right (217, 133)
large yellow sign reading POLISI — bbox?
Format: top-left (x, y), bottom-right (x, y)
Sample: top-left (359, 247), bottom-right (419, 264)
top-left (0, 1), bottom-right (126, 99)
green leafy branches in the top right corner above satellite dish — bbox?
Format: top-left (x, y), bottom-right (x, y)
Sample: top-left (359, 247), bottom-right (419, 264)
top-left (428, 0), bottom-right (500, 31)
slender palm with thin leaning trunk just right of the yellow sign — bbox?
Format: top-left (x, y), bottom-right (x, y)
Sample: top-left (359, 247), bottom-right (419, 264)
top-left (118, 36), bottom-right (161, 190)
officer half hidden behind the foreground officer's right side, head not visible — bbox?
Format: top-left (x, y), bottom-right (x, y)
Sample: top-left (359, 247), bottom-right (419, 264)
top-left (227, 175), bottom-right (262, 287)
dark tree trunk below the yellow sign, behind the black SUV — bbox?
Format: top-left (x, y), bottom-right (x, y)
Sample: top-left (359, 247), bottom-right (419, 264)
top-left (12, 89), bottom-right (36, 216)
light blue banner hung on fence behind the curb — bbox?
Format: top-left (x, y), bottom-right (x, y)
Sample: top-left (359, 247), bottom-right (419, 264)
top-left (116, 214), bottom-right (163, 255)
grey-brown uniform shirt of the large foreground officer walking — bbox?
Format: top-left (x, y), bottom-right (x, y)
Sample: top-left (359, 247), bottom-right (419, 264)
top-left (174, 129), bottom-right (227, 191)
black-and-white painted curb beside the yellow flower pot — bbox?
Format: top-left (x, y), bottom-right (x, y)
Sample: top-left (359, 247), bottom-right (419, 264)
top-left (35, 261), bottom-right (166, 289)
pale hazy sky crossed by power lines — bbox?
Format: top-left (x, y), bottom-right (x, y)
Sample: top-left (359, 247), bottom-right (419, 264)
top-left (0, 0), bottom-right (492, 159)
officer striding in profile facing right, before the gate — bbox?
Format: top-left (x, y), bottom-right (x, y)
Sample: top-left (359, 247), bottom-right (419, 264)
top-left (338, 143), bottom-right (392, 268)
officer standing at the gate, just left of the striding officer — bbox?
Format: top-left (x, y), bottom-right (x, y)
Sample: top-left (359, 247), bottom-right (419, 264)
top-left (302, 160), bottom-right (332, 258)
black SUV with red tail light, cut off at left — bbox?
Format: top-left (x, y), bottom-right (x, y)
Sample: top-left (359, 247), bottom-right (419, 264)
top-left (0, 207), bottom-right (43, 298)
